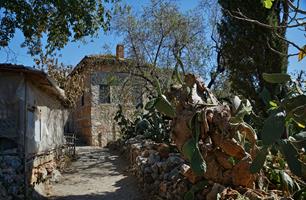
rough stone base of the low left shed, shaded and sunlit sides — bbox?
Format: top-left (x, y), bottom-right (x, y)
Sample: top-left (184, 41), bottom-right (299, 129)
top-left (0, 149), bottom-right (67, 200)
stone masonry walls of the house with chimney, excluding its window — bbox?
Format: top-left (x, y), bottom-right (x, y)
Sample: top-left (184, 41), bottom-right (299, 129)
top-left (73, 60), bottom-right (142, 146)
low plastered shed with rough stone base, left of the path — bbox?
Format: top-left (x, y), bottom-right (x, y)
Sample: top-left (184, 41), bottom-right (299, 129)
top-left (0, 64), bottom-right (68, 199)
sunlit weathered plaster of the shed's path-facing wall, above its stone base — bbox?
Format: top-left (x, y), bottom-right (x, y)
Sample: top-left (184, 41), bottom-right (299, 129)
top-left (27, 82), bottom-right (67, 154)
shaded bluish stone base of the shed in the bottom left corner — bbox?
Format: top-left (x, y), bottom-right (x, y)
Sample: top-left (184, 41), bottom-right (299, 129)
top-left (0, 155), bottom-right (24, 199)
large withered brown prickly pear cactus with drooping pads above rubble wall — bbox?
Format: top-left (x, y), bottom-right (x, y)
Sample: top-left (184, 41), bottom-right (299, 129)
top-left (156, 74), bottom-right (257, 187)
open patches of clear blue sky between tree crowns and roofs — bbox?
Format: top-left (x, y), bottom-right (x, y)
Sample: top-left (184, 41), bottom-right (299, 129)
top-left (0, 0), bottom-right (306, 72)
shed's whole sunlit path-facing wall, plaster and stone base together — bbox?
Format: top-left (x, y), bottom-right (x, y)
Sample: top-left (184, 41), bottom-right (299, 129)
top-left (26, 80), bottom-right (68, 195)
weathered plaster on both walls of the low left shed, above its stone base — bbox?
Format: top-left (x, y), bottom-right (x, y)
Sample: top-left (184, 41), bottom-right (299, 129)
top-left (0, 73), bottom-right (68, 153)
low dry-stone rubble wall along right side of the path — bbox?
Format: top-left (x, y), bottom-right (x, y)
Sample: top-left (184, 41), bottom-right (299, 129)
top-left (114, 135), bottom-right (290, 200)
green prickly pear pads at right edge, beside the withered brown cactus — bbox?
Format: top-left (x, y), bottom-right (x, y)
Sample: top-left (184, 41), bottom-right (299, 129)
top-left (250, 74), bottom-right (306, 199)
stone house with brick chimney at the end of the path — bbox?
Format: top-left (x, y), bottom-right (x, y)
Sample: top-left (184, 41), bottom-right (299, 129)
top-left (71, 45), bottom-right (145, 147)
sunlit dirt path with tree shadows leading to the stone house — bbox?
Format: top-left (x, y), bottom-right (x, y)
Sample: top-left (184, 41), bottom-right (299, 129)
top-left (49, 147), bottom-right (144, 200)
